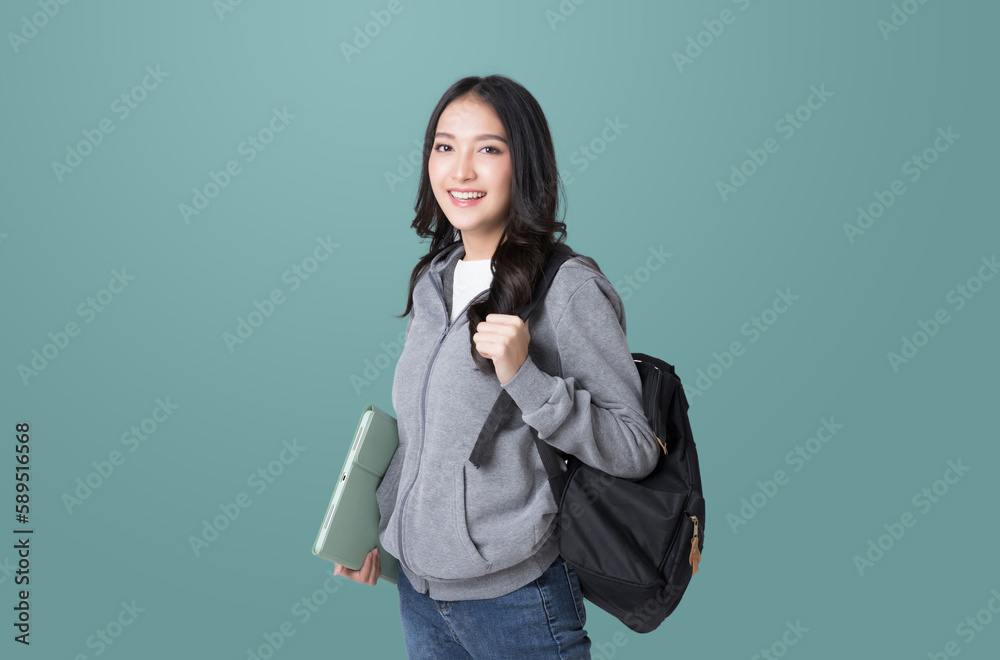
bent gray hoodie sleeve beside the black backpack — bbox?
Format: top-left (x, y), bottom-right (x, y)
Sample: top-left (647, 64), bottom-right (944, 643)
top-left (501, 277), bottom-right (661, 479)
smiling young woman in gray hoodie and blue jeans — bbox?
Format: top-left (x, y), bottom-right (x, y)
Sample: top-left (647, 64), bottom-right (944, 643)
top-left (335, 75), bottom-right (659, 660)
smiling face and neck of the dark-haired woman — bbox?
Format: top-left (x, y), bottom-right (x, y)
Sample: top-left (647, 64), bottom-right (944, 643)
top-left (427, 96), bottom-right (511, 260)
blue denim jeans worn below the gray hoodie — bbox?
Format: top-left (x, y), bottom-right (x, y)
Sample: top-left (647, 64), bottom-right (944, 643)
top-left (396, 556), bottom-right (590, 660)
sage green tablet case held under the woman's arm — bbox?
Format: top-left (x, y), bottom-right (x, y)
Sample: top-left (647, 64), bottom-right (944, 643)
top-left (313, 403), bottom-right (399, 584)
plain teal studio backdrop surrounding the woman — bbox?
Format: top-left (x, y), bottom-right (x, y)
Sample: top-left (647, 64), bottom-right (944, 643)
top-left (0, 0), bottom-right (1000, 660)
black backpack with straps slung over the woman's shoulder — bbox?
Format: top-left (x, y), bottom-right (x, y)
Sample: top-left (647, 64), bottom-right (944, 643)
top-left (469, 243), bottom-right (705, 633)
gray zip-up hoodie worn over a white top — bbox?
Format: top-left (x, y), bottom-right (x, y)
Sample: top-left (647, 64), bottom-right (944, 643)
top-left (377, 240), bottom-right (660, 600)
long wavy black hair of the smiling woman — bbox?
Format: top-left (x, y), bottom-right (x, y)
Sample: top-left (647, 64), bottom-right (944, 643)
top-left (400, 75), bottom-right (566, 374)
